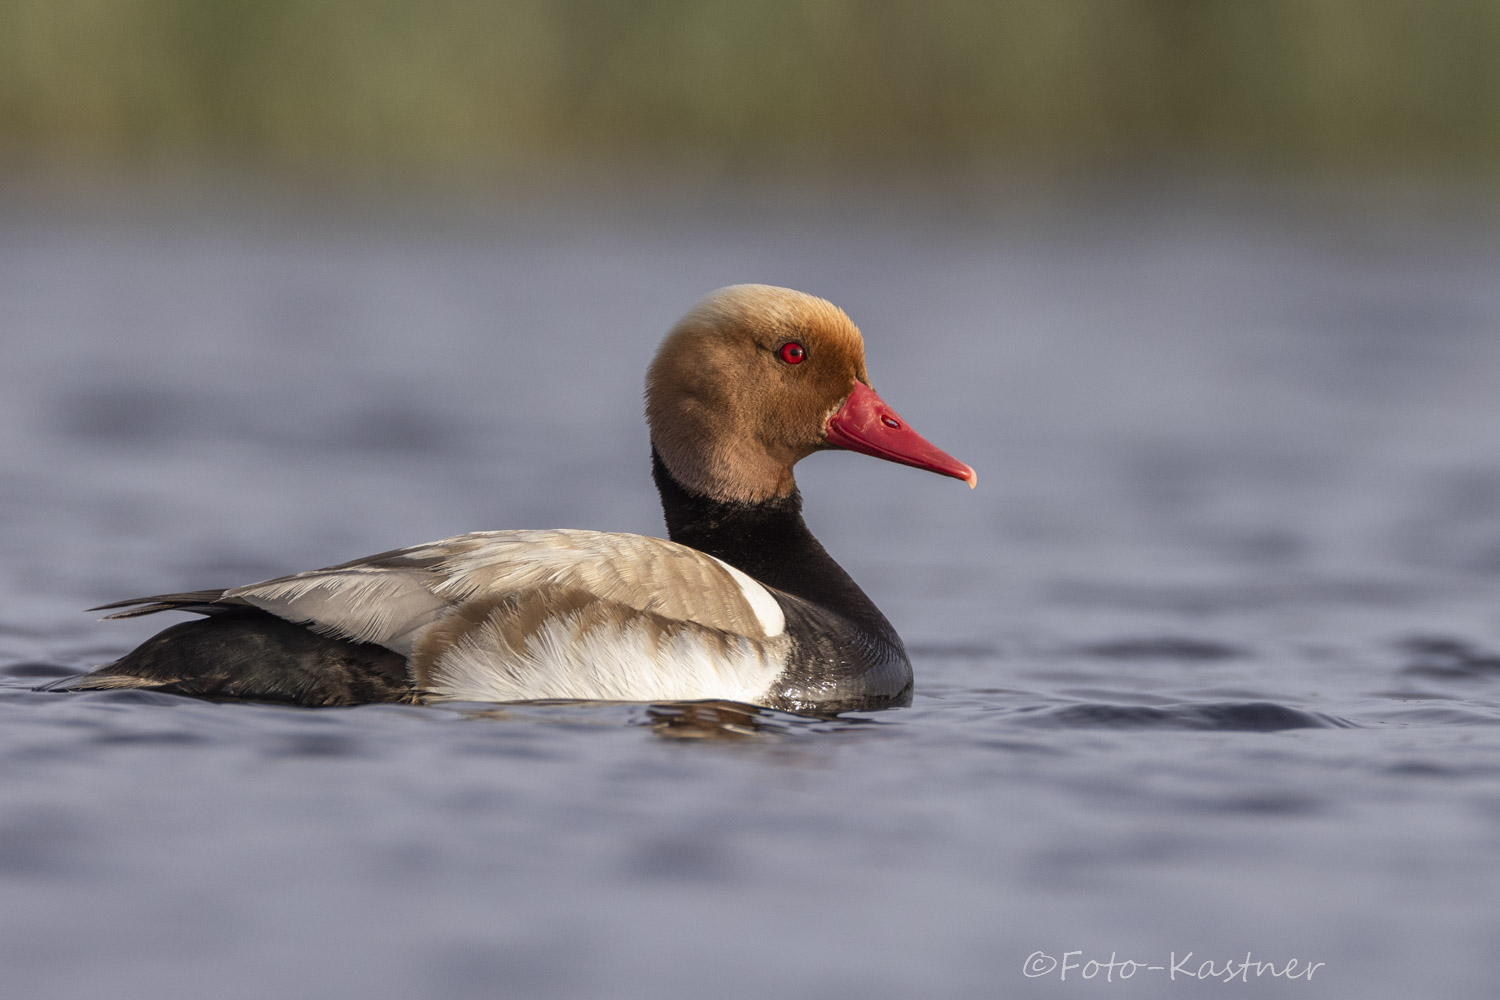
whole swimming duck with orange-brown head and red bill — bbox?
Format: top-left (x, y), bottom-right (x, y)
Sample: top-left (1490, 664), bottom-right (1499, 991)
top-left (54, 285), bottom-right (977, 715)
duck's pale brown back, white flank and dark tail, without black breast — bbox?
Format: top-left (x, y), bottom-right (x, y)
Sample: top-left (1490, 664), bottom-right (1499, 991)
top-left (72, 529), bottom-right (791, 705)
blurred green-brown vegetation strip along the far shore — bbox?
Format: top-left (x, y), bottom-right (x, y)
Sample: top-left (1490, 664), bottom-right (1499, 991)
top-left (0, 0), bottom-right (1500, 175)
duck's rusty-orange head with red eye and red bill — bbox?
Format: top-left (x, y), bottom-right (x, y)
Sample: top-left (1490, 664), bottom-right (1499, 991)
top-left (647, 285), bottom-right (977, 502)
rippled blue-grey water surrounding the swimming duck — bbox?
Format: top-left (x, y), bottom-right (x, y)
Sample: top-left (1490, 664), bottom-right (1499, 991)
top-left (0, 182), bottom-right (1500, 999)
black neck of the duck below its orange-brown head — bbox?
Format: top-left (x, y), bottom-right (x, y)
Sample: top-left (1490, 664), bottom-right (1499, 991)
top-left (651, 448), bottom-right (896, 637)
